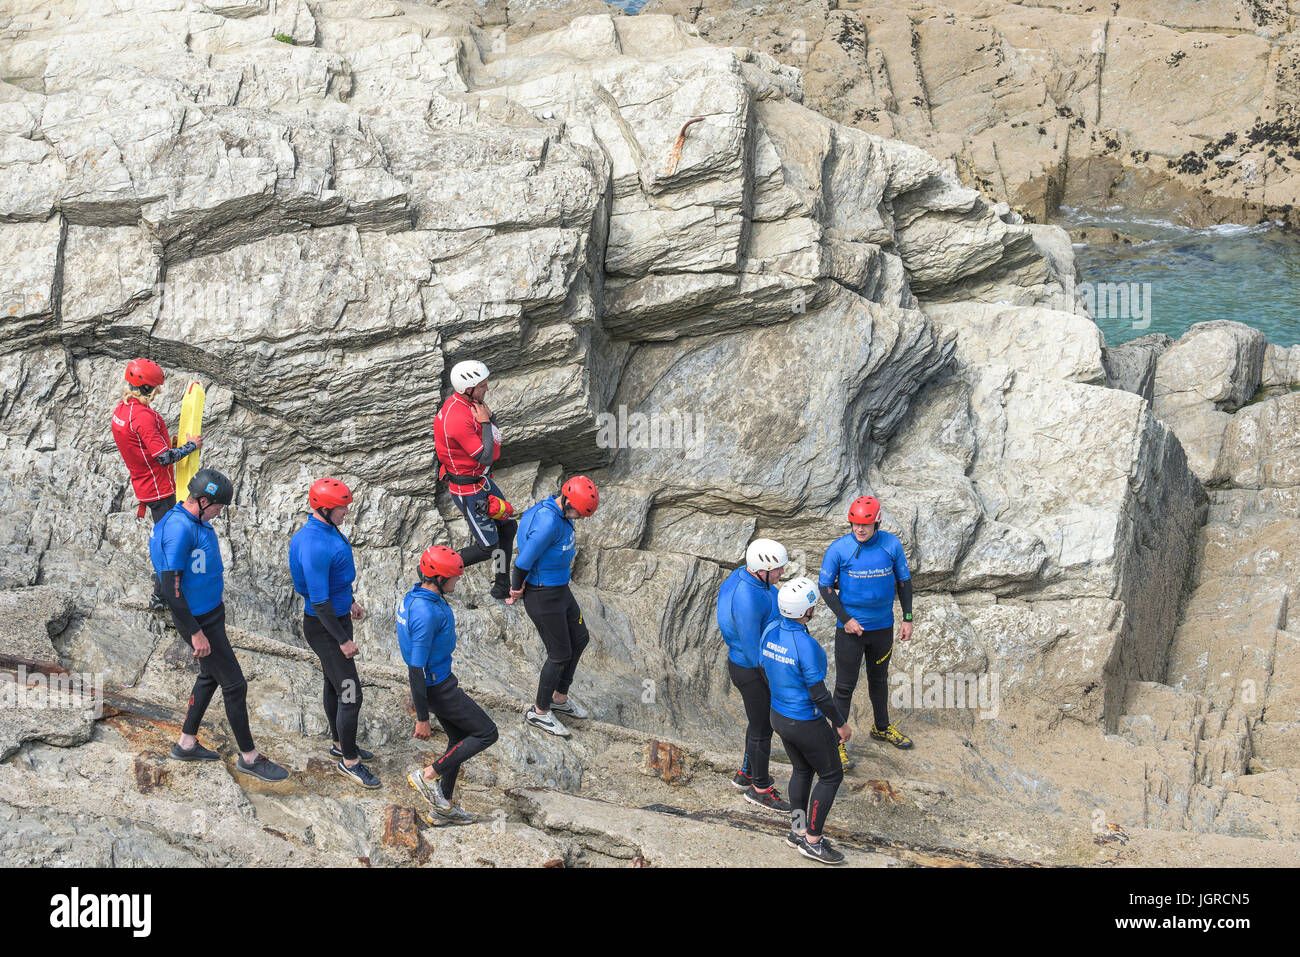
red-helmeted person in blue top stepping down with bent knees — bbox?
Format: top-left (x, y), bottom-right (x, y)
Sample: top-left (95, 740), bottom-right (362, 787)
top-left (398, 545), bottom-right (497, 824)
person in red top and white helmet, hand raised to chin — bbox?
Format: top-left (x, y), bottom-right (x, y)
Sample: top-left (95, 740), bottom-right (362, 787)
top-left (433, 359), bottom-right (517, 601)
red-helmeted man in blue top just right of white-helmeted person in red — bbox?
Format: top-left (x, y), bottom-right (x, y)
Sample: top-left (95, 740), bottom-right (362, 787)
top-left (506, 475), bottom-right (601, 737)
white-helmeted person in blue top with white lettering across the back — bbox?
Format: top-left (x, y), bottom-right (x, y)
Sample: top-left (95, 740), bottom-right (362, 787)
top-left (759, 576), bottom-right (853, 863)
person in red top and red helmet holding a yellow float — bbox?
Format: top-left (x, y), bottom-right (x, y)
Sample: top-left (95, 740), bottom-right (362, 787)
top-left (113, 359), bottom-right (203, 611)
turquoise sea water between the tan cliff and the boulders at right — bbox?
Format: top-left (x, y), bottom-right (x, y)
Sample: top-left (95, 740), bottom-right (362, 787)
top-left (1058, 208), bottom-right (1300, 346)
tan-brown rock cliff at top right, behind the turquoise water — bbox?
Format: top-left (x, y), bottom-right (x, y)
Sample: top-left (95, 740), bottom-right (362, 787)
top-left (439, 0), bottom-right (1300, 225)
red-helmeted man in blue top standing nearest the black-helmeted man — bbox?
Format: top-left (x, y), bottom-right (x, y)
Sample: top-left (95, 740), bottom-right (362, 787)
top-left (289, 479), bottom-right (380, 788)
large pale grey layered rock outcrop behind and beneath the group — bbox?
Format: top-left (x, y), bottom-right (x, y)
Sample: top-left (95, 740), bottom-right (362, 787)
top-left (0, 0), bottom-right (1294, 863)
